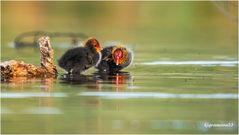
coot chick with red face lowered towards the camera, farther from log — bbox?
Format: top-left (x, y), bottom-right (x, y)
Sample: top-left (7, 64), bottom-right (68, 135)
top-left (96, 46), bottom-right (133, 73)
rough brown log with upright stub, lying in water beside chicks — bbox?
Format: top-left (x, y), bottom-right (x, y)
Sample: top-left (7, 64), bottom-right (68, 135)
top-left (0, 37), bottom-right (57, 81)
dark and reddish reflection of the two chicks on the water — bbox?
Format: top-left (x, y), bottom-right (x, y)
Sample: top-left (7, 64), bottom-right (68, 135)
top-left (60, 72), bottom-right (133, 91)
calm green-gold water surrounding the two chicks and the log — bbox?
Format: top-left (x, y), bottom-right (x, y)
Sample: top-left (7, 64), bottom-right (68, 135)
top-left (1, 2), bottom-right (238, 134)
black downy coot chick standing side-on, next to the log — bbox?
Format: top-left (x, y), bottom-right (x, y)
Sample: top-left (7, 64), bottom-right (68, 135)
top-left (58, 38), bottom-right (102, 74)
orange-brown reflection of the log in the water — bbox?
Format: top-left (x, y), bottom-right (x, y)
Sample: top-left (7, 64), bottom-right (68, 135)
top-left (1, 77), bottom-right (58, 113)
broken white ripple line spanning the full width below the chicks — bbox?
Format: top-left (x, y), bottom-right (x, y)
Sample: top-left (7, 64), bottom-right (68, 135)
top-left (1, 92), bottom-right (238, 99)
